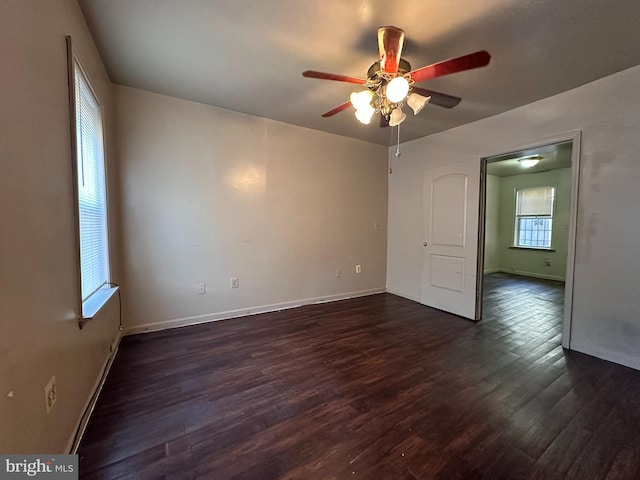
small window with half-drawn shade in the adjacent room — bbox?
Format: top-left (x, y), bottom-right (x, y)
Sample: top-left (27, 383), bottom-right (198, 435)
top-left (513, 187), bottom-right (555, 248)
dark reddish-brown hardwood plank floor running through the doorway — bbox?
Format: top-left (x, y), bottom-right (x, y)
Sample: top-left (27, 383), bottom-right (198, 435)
top-left (78, 274), bottom-right (640, 480)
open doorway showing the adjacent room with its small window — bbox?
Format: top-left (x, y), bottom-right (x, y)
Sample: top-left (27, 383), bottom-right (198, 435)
top-left (476, 132), bottom-right (580, 348)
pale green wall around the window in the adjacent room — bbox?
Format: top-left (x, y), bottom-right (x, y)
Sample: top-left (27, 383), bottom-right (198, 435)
top-left (498, 168), bottom-right (571, 280)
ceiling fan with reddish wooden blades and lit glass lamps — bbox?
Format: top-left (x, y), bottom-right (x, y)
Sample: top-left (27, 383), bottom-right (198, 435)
top-left (302, 26), bottom-right (491, 127)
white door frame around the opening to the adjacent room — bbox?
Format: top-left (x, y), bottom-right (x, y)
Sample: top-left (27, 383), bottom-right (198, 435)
top-left (475, 130), bottom-right (582, 350)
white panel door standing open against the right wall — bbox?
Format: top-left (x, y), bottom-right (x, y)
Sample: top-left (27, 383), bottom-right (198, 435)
top-left (420, 160), bottom-right (480, 320)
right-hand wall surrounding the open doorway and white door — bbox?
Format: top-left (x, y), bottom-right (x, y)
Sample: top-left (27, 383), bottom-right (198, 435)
top-left (387, 63), bottom-right (640, 369)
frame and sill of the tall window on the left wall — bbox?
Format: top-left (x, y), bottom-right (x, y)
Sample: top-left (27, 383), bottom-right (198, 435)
top-left (66, 36), bottom-right (117, 329)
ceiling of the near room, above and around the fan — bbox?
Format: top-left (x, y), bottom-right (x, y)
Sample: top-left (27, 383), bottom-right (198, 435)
top-left (79, 0), bottom-right (640, 145)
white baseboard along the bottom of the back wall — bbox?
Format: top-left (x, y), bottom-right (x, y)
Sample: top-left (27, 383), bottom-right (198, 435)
top-left (124, 288), bottom-right (386, 335)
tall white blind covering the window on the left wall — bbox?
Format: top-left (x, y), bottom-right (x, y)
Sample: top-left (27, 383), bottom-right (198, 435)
top-left (74, 63), bottom-right (109, 302)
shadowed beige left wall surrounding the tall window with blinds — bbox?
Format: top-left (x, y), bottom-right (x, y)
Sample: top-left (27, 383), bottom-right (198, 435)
top-left (0, 0), bottom-right (118, 454)
